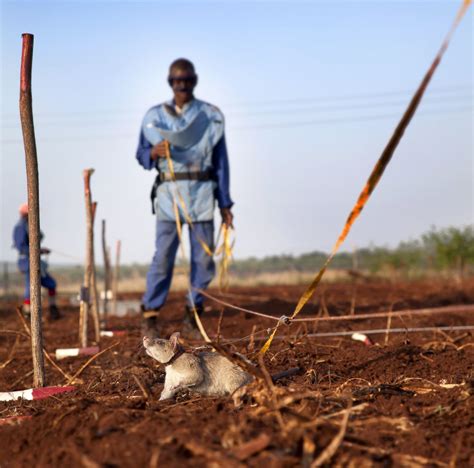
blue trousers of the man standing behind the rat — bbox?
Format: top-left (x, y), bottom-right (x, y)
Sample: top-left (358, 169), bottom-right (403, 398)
top-left (142, 221), bottom-right (216, 310)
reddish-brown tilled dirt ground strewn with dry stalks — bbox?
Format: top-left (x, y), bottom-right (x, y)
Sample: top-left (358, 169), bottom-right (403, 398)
top-left (0, 279), bottom-right (474, 468)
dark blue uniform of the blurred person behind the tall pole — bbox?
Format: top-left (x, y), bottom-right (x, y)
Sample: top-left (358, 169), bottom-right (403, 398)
top-left (13, 217), bottom-right (56, 303)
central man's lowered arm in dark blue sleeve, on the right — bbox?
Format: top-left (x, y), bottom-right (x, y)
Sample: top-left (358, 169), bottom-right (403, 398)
top-left (212, 136), bottom-right (234, 226)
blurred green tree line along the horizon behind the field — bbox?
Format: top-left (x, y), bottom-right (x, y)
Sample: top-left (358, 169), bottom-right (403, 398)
top-left (0, 225), bottom-right (474, 288)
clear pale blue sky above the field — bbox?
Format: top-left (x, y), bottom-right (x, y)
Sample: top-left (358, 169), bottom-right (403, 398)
top-left (0, 0), bottom-right (474, 262)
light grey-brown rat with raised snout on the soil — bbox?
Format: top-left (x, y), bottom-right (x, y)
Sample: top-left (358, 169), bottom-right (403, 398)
top-left (143, 333), bottom-right (253, 400)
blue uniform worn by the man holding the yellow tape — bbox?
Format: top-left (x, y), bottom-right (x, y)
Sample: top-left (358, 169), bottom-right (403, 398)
top-left (136, 99), bottom-right (233, 309)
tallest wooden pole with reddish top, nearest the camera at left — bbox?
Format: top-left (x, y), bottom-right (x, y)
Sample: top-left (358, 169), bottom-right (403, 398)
top-left (20, 34), bottom-right (46, 387)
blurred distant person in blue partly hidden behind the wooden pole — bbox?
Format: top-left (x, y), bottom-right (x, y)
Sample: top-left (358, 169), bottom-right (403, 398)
top-left (13, 203), bottom-right (60, 320)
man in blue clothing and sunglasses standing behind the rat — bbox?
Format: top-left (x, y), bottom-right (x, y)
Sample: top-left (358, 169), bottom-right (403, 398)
top-left (136, 59), bottom-right (233, 337)
